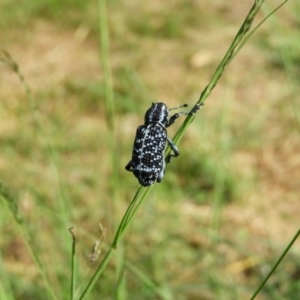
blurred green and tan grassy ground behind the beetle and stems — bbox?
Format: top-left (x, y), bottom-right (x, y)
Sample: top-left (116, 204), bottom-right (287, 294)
top-left (0, 0), bottom-right (300, 300)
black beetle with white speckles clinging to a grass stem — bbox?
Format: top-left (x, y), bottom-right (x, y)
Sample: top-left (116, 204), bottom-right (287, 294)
top-left (125, 102), bottom-right (201, 187)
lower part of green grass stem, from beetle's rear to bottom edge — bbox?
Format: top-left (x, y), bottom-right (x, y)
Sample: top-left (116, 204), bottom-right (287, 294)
top-left (79, 186), bottom-right (152, 300)
